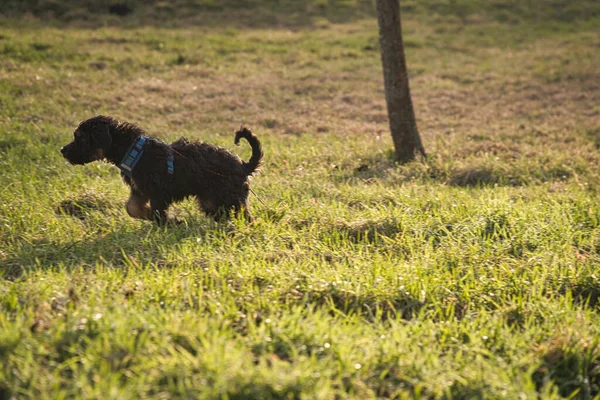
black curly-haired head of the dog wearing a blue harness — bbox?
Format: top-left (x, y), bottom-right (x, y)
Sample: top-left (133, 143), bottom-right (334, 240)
top-left (60, 115), bottom-right (117, 164)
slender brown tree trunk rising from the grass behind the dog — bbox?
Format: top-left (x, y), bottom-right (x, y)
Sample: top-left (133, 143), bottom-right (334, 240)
top-left (377, 0), bottom-right (425, 162)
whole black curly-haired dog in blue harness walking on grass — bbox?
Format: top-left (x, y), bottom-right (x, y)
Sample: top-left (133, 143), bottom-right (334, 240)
top-left (60, 115), bottom-right (263, 224)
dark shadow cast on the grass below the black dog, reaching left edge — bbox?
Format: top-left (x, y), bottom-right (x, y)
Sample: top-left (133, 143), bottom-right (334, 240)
top-left (0, 196), bottom-right (234, 280)
